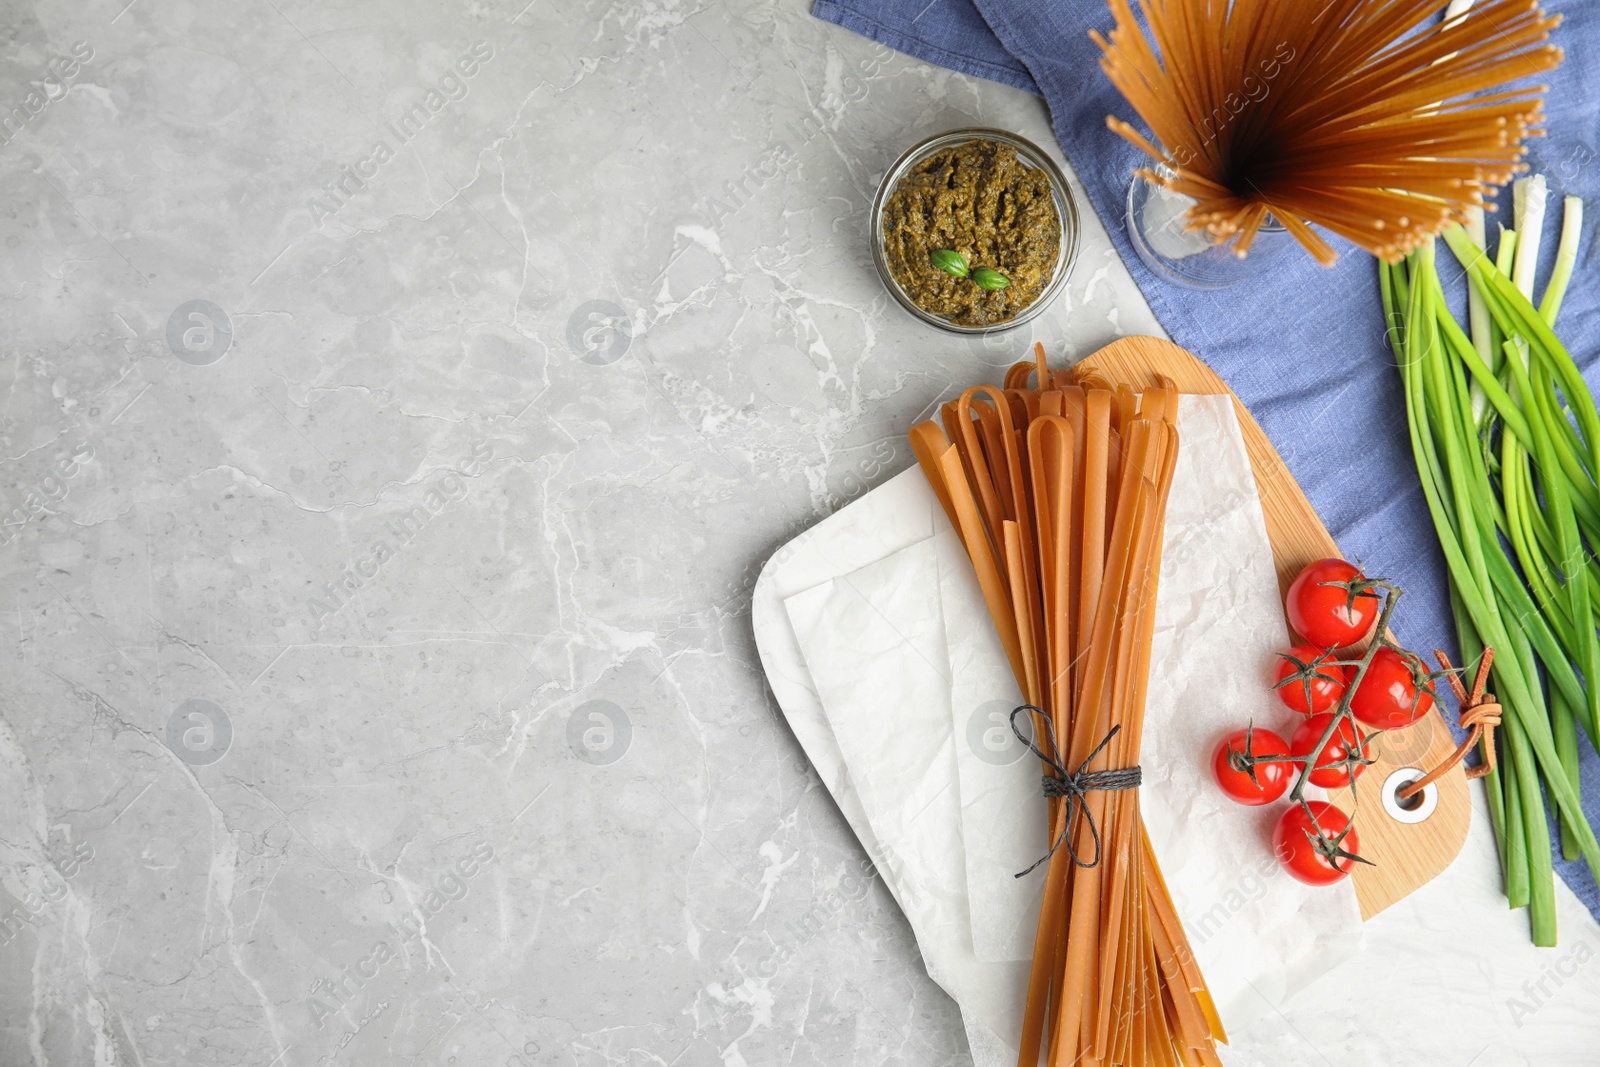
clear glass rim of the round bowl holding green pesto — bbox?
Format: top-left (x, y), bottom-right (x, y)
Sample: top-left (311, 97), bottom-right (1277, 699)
top-left (872, 126), bottom-right (1078, 334)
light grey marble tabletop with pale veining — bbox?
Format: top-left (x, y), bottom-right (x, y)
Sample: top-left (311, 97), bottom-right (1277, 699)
top-left (9, 0), bottom-right (1587, 1067)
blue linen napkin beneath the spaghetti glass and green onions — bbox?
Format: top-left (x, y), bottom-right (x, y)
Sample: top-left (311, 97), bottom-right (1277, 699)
top-left (813, 0), bottom-right (1600, 920)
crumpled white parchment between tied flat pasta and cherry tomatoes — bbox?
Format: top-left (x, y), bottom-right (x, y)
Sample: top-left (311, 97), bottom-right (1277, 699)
top-left (1139, 397), bottom-right (1362, 1027)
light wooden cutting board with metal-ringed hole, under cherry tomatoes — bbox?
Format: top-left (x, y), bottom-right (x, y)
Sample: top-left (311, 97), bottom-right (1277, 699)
top-left (1082, 338), bottom-right (1472, 918)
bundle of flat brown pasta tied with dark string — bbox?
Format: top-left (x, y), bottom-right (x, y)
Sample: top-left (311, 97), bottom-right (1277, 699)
top-left (910, 346), bottom-right (1224, 1067)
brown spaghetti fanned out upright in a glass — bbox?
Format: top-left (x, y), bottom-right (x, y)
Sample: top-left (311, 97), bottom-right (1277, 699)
top-left (1091, 0), bottom-right (1562, 264)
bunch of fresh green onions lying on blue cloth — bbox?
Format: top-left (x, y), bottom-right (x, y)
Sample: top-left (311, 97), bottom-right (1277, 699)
top-left (1379, 182), bottom-right (1600, 945)
